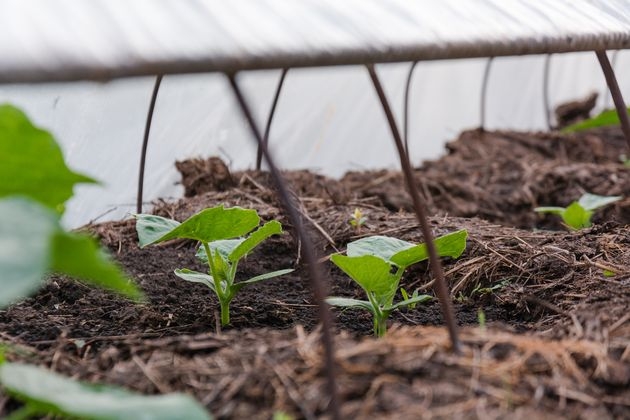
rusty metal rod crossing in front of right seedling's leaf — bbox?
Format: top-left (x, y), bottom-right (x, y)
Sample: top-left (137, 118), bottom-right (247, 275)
top-left (366, 64), bottom-right (461, 353)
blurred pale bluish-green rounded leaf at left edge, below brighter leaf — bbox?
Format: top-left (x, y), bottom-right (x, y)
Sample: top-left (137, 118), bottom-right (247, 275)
top-left (0, 197), bottom-right (61, 307)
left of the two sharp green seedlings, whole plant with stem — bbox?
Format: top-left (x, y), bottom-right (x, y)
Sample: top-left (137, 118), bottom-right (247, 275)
top-left (135, 206), bottom-right (293, 325)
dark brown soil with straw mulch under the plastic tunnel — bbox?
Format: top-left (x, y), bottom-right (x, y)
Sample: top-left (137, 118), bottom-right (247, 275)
top-left (0, 124), bottom-right (630, 419)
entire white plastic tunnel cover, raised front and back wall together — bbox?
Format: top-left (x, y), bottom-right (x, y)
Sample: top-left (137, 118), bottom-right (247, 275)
top-left (0, 0), bottom-right (630, 226)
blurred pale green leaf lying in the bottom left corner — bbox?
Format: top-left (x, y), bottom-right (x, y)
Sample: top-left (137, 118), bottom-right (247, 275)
top-left (0, 363), bottom-right (211, 420)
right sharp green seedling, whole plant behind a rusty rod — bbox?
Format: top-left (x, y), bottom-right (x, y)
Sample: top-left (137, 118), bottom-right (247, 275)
top-left (326, 230), bottom-right (468, 337)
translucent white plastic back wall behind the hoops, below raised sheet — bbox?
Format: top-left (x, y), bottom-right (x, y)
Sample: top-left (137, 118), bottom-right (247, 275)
top-left (0, 52), bottom-right (630, 226)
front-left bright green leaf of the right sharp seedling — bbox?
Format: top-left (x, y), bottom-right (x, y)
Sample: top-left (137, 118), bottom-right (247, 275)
top-left (330, 254), bottom-right (398, 304)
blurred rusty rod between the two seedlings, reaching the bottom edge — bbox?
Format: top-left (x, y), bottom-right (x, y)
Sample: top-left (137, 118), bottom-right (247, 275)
top-left (226, 74), bottom-right (341, 420)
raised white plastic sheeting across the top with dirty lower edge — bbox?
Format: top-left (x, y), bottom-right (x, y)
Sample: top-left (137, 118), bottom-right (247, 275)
top-left (0, 0), bottom-right (630, 82)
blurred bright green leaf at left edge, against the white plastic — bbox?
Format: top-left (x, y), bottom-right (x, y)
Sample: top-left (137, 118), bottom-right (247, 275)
top-left (0, 105), bottom-right (96, 213)
